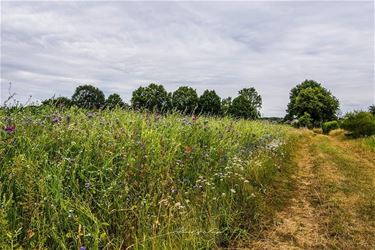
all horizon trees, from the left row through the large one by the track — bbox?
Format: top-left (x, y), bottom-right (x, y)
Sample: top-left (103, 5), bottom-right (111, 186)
top-left (43, 80), bottom-right (368, 127)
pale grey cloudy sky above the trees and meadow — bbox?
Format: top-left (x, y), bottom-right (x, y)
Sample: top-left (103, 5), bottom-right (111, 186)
top-left (1, 1), bottom-right (375, 116)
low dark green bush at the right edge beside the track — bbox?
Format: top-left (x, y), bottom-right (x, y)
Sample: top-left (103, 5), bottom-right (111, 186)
top-left (341, 111), bottom-right (375, 137)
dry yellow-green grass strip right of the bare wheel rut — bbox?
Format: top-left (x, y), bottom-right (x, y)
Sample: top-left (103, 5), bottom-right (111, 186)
top-left (313, 137), bottom-right (375, 249)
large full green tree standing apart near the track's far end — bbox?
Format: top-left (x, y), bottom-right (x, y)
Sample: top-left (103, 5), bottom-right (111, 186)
top-left (286, 80), bottom-right (339, 127)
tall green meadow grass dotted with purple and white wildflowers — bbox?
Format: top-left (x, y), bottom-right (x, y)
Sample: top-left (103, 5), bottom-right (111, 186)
top-left (0, 108), bottom-right (293, 249)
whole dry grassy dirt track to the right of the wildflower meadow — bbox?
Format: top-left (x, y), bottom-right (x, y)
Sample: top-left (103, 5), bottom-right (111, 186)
top-left (251, 131), bottom-right (375, 249)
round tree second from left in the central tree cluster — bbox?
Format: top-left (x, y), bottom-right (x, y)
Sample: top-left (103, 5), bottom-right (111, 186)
top-left (172, 86), bottom-right (199, 114)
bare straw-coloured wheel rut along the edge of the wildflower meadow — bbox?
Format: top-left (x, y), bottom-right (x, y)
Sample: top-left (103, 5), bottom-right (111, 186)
top-left (252, 132), bottom-right (325, 249)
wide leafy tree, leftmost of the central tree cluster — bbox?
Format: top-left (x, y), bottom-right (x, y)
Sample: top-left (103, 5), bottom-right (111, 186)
top-left (131, 83), bottom-right (168, 112)
